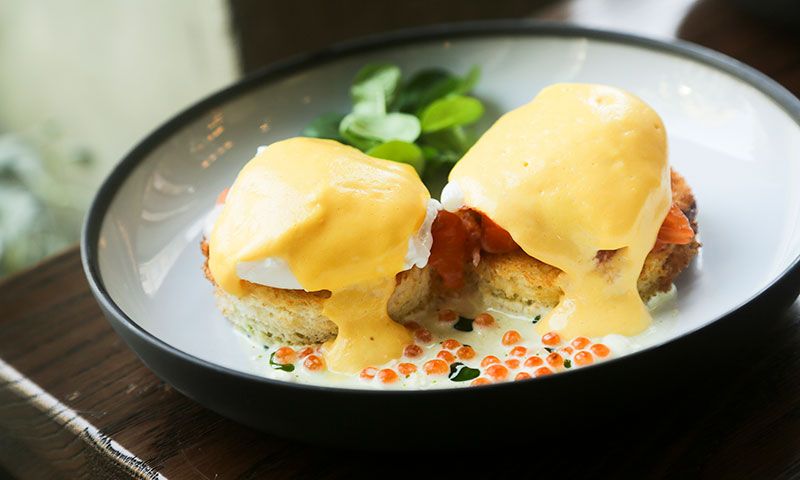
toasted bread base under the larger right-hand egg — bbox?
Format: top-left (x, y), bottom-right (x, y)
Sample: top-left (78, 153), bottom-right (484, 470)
top-left (468, 171), bottom-right (700, 316)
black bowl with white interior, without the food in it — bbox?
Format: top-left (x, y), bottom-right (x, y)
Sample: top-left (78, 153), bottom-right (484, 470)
top-left (82, 22), bottom-right (800, 448)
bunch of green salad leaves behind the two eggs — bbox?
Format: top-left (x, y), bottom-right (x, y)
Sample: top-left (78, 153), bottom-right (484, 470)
top-left (301, 63), bottom-right (485, 178)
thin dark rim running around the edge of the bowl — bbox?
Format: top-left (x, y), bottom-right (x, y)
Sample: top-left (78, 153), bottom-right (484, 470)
top-left (80, 19), bottom-right (800, 396)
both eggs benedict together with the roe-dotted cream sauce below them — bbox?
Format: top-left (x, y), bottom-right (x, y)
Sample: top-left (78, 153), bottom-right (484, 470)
top-left (201, 83), bottom-right (700, 389)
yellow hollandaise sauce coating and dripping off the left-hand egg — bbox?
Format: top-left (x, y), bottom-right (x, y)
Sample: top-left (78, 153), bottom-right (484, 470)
top-left (209, 138), bottom-right (430, 373)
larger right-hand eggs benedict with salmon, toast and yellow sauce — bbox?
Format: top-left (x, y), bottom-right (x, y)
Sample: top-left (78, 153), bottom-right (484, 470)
top-left (432, 84), bottom-right (698, 337)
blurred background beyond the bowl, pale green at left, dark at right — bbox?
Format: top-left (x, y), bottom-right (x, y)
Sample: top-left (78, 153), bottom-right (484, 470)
top-left (0, 0), bottom-right (800, 276)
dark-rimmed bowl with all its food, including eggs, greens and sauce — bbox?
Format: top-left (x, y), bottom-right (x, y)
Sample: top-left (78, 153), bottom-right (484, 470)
top-left (81, 22), bottom-right (800, 442)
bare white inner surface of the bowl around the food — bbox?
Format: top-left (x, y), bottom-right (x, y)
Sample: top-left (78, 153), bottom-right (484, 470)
top-left (99, 36), bottom-right (800, 372)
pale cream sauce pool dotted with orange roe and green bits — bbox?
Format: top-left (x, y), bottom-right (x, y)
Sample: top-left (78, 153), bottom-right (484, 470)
top-left (237, 287), bottom-right (678, 390)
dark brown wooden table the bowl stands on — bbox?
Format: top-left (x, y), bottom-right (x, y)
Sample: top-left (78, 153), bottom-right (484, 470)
top-left (0, 0), bottom-right (800, 479)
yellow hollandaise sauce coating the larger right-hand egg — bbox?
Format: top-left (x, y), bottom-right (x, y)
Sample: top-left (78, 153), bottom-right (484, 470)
top-left (450, 84), bottom-right (672, 338)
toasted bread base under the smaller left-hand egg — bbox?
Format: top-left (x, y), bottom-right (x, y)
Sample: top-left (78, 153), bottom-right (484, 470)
top-left (200, 240), bottom-right (430, 345)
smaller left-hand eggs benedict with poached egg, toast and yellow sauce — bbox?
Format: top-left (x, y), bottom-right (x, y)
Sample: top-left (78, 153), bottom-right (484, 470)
top-left (205, 138), bottom-right (436, 372)
